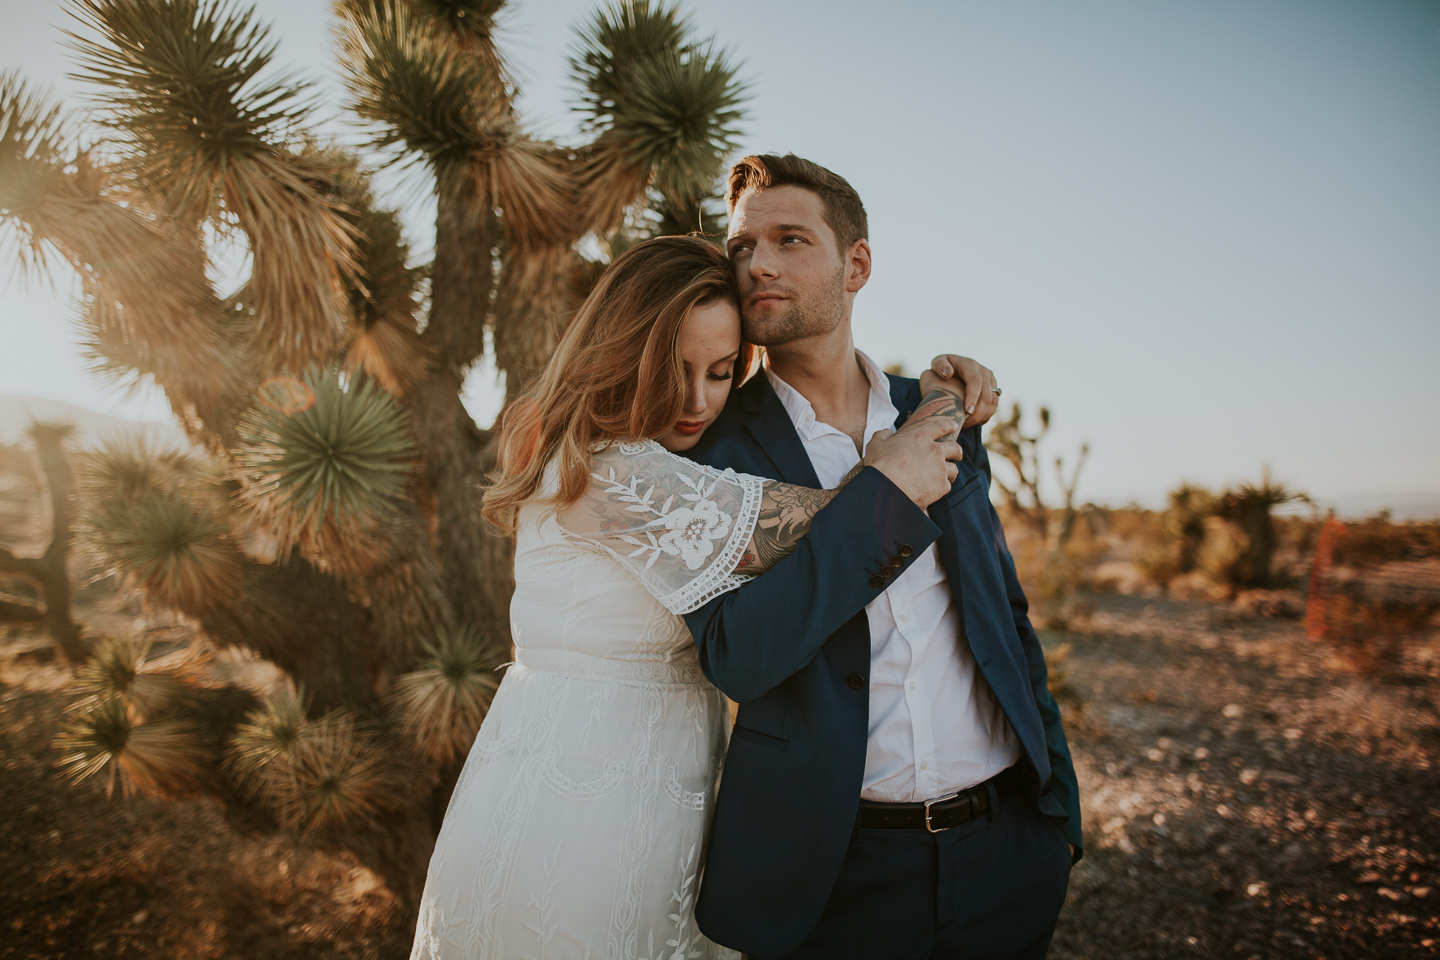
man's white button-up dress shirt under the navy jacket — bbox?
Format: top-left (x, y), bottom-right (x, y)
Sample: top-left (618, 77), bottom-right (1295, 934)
top-left (765, 350), bottom-right (1021, 802)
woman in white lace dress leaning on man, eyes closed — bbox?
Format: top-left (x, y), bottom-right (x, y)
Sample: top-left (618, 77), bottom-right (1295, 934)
top-left (412, 237), bottom-right (959, 960)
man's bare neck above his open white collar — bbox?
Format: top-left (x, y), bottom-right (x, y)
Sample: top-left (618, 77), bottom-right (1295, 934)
top-left (766, 322), bottom-right (870, 448)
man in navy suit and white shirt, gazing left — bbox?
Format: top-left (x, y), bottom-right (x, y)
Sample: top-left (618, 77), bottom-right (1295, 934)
top-left (685, 155), bottom-right (1081, 960)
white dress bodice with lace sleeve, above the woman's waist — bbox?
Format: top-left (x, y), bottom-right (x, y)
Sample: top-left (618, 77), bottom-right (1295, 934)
top-left (510, 442), bottom-right (763, 682)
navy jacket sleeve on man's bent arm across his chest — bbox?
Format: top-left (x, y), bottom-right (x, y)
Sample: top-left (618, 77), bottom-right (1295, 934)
top-left (685, 468), bottom-right (940, 704)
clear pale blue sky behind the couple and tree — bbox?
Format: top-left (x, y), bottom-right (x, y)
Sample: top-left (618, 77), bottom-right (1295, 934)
top-left (0, 0), bottom-right (1440, 502)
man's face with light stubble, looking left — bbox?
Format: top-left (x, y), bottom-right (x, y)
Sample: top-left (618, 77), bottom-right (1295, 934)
top-left (726, 186), bottom-right (868, 347)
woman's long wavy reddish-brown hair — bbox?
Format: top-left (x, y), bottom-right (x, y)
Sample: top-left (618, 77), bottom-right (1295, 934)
top-left (481, 236), bottom-right (755, 535)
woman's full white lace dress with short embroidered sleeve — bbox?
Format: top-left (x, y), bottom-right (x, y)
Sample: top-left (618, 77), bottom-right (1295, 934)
top-left (410, 442), bottom-right (763, 960)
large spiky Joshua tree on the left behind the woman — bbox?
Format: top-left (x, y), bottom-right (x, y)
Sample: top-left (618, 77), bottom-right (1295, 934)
top-left (0, 0), bottom-right (743, 902)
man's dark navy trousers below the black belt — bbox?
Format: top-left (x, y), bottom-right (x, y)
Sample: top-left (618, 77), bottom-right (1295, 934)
top-left (783, 794), bottom-right (1070, 960)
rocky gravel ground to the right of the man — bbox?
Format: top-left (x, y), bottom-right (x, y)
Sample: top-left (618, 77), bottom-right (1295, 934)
top-left (1045, 596), bottom-right (1440, 960)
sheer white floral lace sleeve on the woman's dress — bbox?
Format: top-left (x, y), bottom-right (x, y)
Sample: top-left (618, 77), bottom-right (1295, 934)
top-left (556, 440), bottom-right (765, 613)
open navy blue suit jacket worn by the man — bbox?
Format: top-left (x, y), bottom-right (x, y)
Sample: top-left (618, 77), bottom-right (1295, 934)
top-left (685, 374), bottom-right (1080, 956)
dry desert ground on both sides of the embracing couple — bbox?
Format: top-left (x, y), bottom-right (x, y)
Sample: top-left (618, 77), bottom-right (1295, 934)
top-left (0, 446), bottom-right (1440, 960)
